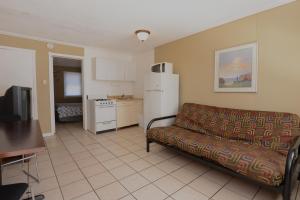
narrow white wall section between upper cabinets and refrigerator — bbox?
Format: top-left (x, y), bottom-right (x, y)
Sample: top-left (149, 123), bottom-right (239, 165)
top-left (133, 49), bottom-right (154, 98)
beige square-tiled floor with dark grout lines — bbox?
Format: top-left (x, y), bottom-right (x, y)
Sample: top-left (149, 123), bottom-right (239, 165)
top-left (3, 124), bottom-right (300, 200)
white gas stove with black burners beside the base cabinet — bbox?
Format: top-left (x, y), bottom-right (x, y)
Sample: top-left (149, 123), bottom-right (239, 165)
top-left (88, 98), bottom-right (117, 134)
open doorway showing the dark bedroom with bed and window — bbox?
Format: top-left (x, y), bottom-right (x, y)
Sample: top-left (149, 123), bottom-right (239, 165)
top-left (49, 53), bottom-right (84, 134)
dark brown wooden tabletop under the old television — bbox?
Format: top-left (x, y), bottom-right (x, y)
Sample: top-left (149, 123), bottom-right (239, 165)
top-left (0, 120), bottom-right (45, 184)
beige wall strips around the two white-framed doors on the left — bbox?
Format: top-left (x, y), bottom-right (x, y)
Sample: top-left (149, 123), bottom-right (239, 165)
top-left (0, 34), bottom-right (84, 133)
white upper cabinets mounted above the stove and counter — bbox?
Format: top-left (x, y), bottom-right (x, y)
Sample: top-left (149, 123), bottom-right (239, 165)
top-left (93, 57), bottom-right (136, 81)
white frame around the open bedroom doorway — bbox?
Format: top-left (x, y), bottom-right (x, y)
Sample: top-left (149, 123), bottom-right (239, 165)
top-left (49, 52), bottom-right (86, 135)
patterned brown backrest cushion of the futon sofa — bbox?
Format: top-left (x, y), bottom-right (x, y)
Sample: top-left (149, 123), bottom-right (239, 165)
top-left (175, 103), bottom-right (300, 155)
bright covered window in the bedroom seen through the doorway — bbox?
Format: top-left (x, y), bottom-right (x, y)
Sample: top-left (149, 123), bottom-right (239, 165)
top-left (64, 72), bottom-right (81, 97)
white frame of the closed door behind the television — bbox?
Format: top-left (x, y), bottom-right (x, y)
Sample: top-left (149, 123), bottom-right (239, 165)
top-left (0, 45), bottom-right (39, 120)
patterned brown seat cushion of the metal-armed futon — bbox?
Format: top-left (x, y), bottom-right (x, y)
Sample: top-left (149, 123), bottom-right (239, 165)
top-left (147, 126), bottom-right (286, 186)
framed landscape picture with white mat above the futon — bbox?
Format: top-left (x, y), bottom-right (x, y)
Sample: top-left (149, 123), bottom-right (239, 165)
top-left (214, 43), bottom-right (257, 92)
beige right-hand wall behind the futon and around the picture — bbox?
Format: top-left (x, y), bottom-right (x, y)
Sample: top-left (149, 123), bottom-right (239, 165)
top-left (155, 1), bottom-right (300, 115)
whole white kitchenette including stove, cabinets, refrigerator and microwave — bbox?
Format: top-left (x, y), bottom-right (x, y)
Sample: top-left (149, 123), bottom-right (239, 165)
top-left (83, 48), bottom-right (179, 134)
